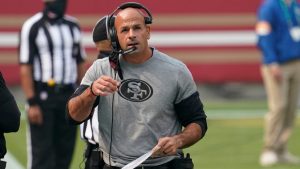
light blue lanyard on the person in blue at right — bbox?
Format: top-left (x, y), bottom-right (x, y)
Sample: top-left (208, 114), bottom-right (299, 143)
top-left (280, 0), bottom-right (300, 28)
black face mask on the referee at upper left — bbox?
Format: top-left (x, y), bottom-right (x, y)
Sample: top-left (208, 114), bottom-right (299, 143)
top-left (45, 0), bottom-right (67, 20)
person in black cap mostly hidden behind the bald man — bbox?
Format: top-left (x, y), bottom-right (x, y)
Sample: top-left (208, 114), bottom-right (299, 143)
top-left (78, 16), bottom-right (111, 169)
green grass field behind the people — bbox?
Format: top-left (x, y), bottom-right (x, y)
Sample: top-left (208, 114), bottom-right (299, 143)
top-left (6, 101), bottom-right (300, 169)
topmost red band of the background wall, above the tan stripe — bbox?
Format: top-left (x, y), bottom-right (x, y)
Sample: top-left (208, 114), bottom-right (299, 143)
top-left (0, 0), bottom-right (261, 14)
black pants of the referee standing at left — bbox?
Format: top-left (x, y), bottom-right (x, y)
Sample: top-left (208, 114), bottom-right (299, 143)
top-left (28, 85), bottom-right (77, 169)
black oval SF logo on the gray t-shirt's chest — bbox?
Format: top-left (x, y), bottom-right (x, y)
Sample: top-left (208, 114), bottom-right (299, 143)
top-left (118, 79), bottom-right (153, 102)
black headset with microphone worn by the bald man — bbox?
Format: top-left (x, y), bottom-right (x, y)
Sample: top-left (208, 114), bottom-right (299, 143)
top-left (108, 2), bottom-right (152, 54)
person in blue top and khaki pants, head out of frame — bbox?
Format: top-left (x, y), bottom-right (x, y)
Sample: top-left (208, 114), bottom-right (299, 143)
top-left (256, 0), bottom-right (300, 166)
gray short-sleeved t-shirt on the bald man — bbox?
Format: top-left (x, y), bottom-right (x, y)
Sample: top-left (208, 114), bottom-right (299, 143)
top-left (81, 49), bottom-right (197, 167)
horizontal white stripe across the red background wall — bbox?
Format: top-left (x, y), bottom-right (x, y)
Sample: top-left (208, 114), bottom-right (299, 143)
top-left (0, 30), bottom-right (256, 47)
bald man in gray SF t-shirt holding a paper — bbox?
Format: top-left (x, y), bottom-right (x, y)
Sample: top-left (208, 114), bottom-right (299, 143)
top-left (67, 4), bottom-right (207, 169)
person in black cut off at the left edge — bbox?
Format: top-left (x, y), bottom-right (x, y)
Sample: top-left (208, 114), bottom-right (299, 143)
top-left (0, 72), bottom-right (21, 169)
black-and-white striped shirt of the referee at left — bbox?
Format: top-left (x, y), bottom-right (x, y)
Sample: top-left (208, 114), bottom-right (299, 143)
top-left (19, 12), bottom-right (86, 84)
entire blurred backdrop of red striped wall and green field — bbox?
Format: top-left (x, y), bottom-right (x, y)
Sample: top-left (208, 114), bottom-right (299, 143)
top-left (0, 0), bottom-right (300, 169)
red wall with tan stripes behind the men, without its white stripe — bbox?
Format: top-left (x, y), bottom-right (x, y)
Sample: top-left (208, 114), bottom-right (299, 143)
top-left (0, 0), bottom-right (261, 84)
